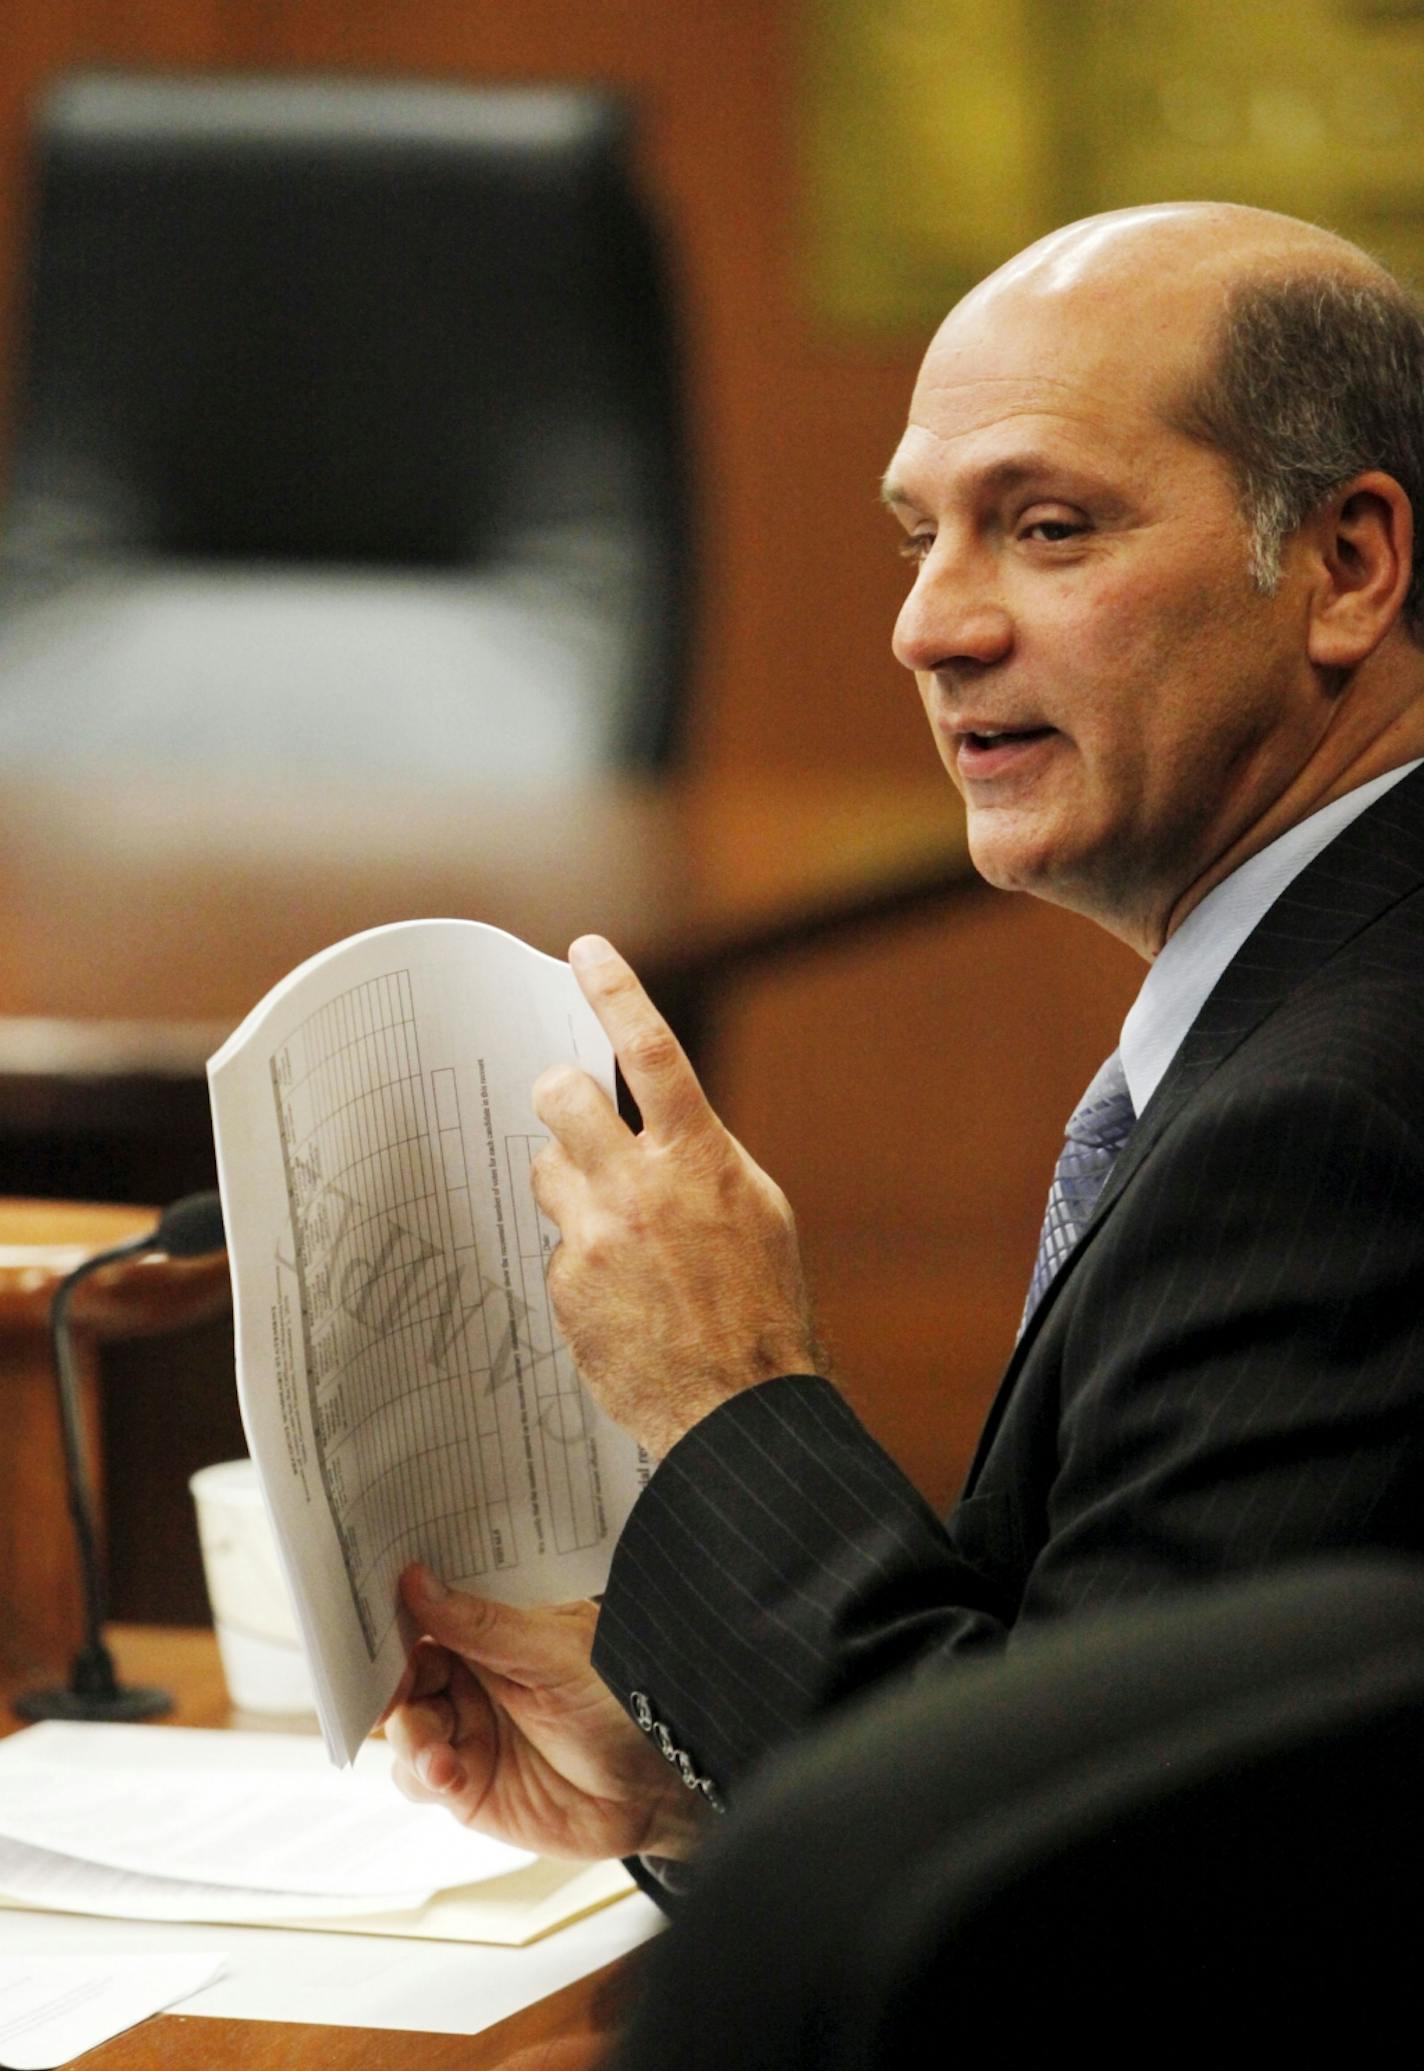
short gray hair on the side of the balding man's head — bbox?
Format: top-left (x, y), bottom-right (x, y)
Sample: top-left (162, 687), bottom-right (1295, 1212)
top-left (1169, 267), bottom-right (1424, 644)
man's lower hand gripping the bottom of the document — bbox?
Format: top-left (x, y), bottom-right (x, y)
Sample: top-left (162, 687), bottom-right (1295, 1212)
top-left (385, 1568), bottom-right (708, 1858)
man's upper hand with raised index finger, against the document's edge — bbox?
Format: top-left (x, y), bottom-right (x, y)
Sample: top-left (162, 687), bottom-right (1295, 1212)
top-left (534, 936), bottom-right (818, 1458)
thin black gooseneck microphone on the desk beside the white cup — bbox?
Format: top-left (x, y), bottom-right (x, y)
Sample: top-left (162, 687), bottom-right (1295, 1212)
top-left (14, 1193), bottom-right (226, 1723)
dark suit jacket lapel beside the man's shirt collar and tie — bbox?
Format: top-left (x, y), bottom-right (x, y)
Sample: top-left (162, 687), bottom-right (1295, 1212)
top-left (965, 768), bottom-right (1424, 1493)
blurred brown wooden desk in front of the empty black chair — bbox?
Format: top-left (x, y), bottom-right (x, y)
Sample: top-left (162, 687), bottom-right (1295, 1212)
top-left (0, 770), bottom-right (977, 1199)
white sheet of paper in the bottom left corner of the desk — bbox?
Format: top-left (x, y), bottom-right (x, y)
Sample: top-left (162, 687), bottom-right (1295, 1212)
top-left (0, 1955), bottom-right (224, 2071)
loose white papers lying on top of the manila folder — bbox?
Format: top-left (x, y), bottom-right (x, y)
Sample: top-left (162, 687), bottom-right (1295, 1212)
top-left (0, 1723), bottom-right (532, 1912)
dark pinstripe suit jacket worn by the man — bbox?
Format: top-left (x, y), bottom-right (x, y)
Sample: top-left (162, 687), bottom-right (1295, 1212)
top-left (594, 770), bottom-right (1424, 1789)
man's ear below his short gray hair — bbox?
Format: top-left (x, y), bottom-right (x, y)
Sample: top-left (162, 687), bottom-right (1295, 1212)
top-left (1306, 470), bottom-right (1414, 669)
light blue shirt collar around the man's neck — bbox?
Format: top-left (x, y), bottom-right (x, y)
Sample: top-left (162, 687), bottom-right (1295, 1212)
top-left (1118, 760), bottom-right (1420, 1114)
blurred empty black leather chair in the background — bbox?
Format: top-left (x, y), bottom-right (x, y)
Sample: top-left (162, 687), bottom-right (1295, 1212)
top-left (0, 75), bottom-right (687, 785)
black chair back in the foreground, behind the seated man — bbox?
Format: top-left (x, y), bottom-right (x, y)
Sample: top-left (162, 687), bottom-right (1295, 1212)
top-left (611, 1557), bottom-right (1424, 2071)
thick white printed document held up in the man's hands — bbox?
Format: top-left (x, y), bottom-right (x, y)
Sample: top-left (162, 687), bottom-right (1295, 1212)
top-left (209, 920), bottom-right (650, 1762)
